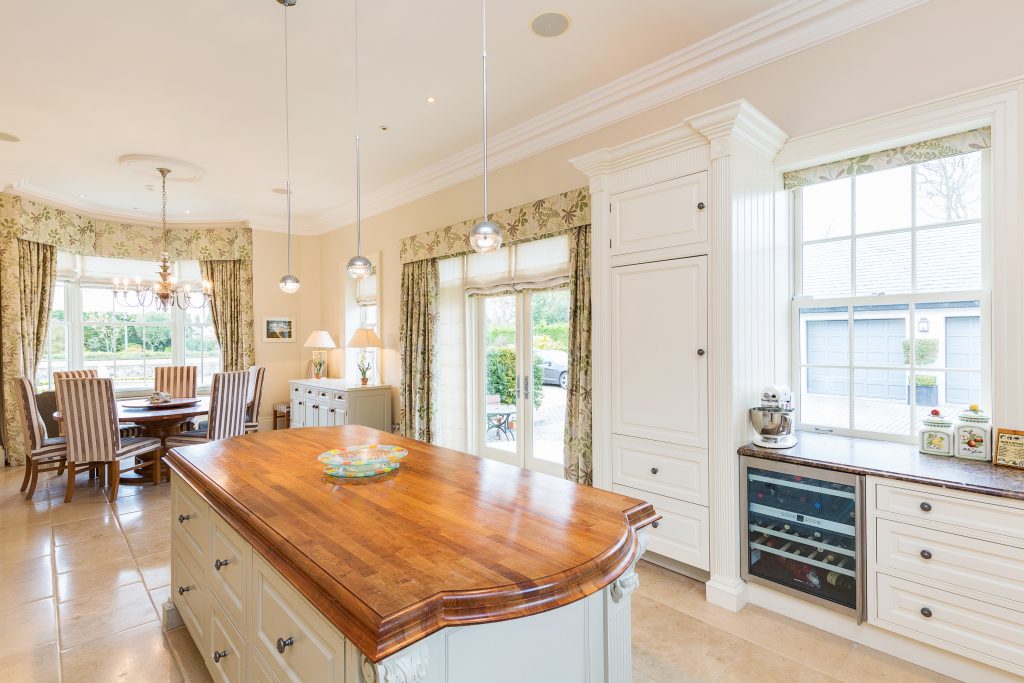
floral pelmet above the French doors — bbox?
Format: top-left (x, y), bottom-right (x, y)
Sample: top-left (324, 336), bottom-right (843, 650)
top-left (400, 187), bottom-right (590, 263)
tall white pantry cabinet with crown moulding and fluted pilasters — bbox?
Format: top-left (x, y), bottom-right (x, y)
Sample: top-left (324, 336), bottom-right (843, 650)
top-left (571, 100), bottom-right (787, 610)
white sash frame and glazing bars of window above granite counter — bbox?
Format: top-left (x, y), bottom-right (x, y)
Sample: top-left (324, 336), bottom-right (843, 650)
top-left (786, 149), bottom-right (994, 443)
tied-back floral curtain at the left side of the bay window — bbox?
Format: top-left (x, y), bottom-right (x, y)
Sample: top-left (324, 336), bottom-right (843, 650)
top-left (17, 240), bottom-right (57, 382)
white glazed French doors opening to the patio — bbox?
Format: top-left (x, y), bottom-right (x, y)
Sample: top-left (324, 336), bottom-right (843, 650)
top-left (472, 288), bottom-right (569, 477)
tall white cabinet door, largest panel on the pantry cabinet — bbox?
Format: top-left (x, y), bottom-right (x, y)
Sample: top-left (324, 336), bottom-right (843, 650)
top-left (611, 256), bottom-right (708, 449)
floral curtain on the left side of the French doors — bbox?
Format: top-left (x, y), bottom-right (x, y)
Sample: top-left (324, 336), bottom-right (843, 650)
top-left (398, 258), bottom-right (440, 443)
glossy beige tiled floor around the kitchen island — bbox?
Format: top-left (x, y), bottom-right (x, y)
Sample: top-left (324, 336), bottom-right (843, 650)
top-left (0, 468), bottom-right (950, 683)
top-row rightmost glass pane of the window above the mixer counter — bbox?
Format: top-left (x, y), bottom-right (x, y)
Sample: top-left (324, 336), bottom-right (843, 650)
top-left (915, 152), bottom-right (981, 225)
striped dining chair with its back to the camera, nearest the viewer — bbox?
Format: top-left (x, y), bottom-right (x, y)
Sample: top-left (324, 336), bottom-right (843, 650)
top-left (56, 377), bottom-right (160, 503)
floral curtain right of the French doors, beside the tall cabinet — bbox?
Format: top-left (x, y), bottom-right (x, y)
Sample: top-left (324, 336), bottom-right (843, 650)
top-left (565, 225), bottom-right (594, 485)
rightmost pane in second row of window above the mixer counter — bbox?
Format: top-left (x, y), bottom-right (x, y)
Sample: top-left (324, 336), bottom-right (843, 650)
top-left (918, 224), bottom-right (981, 292)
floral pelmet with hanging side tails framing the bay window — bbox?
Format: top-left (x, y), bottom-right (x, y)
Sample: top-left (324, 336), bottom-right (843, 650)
top-left (0, 193), bottom-right (253, 465)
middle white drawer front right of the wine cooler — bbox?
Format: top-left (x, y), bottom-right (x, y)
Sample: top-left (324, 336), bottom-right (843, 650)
top-left (876, 519), bottom-right (1024, 608)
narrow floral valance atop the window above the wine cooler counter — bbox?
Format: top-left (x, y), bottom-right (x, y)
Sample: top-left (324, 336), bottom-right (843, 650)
top-left (782, 128), bottom-right (992, 189)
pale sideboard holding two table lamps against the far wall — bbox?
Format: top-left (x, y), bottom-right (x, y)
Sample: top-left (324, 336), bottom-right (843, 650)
top-left (288, 379), bottom-right (391, 432)
